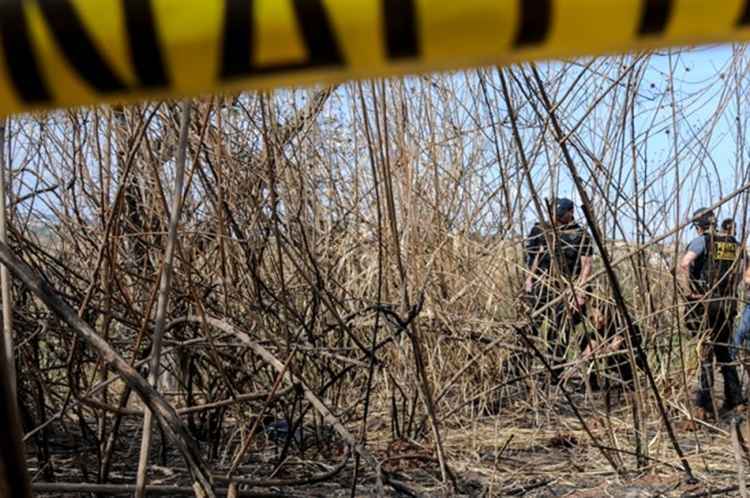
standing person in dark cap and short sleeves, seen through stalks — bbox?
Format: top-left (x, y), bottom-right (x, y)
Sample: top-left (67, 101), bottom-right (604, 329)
top-left (524, 198), bottom-right (593, 383)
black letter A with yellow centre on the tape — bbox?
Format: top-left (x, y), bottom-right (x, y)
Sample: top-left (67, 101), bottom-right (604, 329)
top-left (219, 0), bottom-right (344, 80)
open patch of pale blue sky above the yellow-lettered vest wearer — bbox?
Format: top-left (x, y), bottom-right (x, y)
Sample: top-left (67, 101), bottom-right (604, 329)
top-left (536, 45), bottom-right (750, 243)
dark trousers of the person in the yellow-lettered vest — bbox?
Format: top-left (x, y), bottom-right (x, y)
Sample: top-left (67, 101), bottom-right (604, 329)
top-left (688, 299), bottom-right (743, 410)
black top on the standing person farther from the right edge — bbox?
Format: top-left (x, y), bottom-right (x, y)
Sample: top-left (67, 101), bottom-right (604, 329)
top-left (526, 222), bottom-right (594, 278)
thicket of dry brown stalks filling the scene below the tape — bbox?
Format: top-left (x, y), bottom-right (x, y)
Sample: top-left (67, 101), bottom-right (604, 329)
top-left (0, 47), bottom-right (750, 496)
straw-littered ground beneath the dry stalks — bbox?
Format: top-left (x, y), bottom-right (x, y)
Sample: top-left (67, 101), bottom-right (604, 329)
top-left (28, 380), bottom-right (749, 498)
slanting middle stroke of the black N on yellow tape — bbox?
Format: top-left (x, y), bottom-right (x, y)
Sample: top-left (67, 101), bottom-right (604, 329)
top-left (39, 0), bottom-right (127, 93)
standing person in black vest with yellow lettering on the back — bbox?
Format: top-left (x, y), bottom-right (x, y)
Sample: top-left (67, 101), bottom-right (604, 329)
top-left (677, 209), bottom-right (745, 417)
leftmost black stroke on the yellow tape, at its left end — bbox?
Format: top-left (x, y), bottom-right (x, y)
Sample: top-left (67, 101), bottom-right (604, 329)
top-left (0, 0), bottom-right (52, 104)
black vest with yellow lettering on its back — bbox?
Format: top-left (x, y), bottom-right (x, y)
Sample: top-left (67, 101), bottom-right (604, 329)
top-left (690, 233), bottom-right (742, 297)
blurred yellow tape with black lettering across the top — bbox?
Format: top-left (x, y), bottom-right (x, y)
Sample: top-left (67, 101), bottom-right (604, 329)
top-left (0, 0), bottom-right (750, 116)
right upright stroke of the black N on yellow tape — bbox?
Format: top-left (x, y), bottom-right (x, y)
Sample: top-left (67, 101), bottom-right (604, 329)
top-left (121, 0), bottom-right (169, 88)
